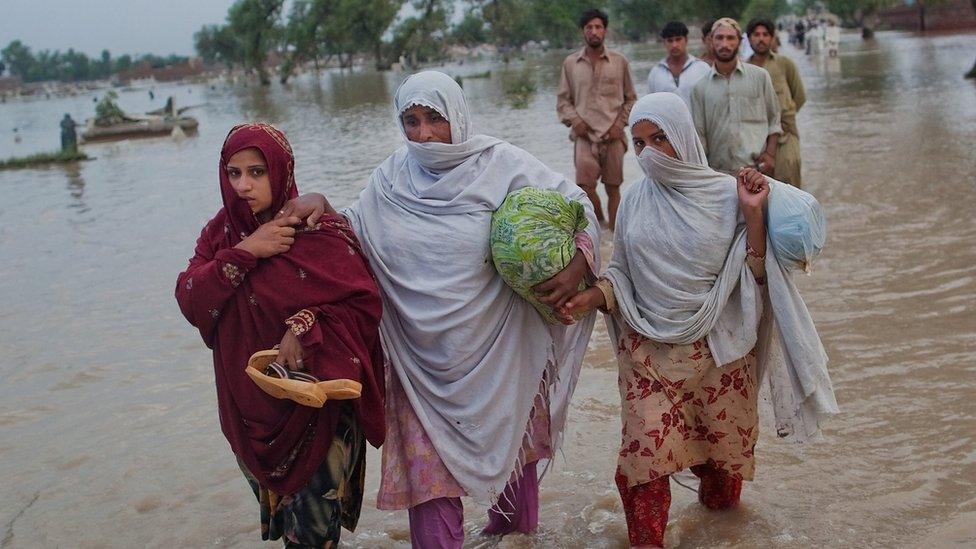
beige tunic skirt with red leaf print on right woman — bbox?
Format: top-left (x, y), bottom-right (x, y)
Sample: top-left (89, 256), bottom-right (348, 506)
top-left (615, 316), bottom-right (759, 486)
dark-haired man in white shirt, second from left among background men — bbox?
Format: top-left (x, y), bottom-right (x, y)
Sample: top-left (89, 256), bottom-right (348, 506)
top-left (647, 21), bottom-right (711, 109)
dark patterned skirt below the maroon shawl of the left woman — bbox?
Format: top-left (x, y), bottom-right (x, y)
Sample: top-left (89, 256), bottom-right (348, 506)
top-left (238, 406), bottom-right (366, 548)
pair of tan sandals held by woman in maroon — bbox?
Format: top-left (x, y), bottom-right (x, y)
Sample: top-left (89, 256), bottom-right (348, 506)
top-left (245, 349), bottom-right (363, 408)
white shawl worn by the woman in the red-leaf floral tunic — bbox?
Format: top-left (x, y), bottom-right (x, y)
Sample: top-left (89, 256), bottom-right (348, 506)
top-left (606, 93), bottom-right (837, 440)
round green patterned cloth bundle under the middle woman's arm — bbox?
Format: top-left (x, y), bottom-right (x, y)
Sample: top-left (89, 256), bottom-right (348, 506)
top-left (491, 187), bottom-right (588, 324)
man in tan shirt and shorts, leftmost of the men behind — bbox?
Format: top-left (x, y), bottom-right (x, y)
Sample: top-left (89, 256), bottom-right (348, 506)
top-left (556, 9), bottom-right (637, 231)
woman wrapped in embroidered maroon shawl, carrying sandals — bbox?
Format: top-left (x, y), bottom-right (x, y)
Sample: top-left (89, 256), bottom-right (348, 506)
top-left (176, 124), bottom-right (385, 547)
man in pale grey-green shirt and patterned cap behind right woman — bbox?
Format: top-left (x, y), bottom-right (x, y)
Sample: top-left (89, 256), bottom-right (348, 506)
top-left (691, 17), bottom-right (783, 176)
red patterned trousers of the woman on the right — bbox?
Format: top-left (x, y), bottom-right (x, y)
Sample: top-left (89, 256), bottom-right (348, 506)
top-left (615, 463), bottom-right (742, 547)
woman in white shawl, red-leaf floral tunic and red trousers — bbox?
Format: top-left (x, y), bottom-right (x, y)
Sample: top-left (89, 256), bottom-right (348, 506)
top-left (561, 93), bottom-right (837, 547)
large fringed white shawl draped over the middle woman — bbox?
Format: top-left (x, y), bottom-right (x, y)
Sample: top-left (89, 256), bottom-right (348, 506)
top-left (342, 71), bottom-right (600, 503)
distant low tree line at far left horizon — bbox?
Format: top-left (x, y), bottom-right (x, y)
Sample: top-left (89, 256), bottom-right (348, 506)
top-left (0, 40), bottom-right (189, 82)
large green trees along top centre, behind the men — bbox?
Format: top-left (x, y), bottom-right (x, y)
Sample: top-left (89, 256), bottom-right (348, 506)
top-left (194, 0), bottom-right (808, 84)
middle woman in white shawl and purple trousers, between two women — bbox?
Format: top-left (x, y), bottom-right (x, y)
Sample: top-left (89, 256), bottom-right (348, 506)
top-left (283, 71), bottom-right (599, 548)
